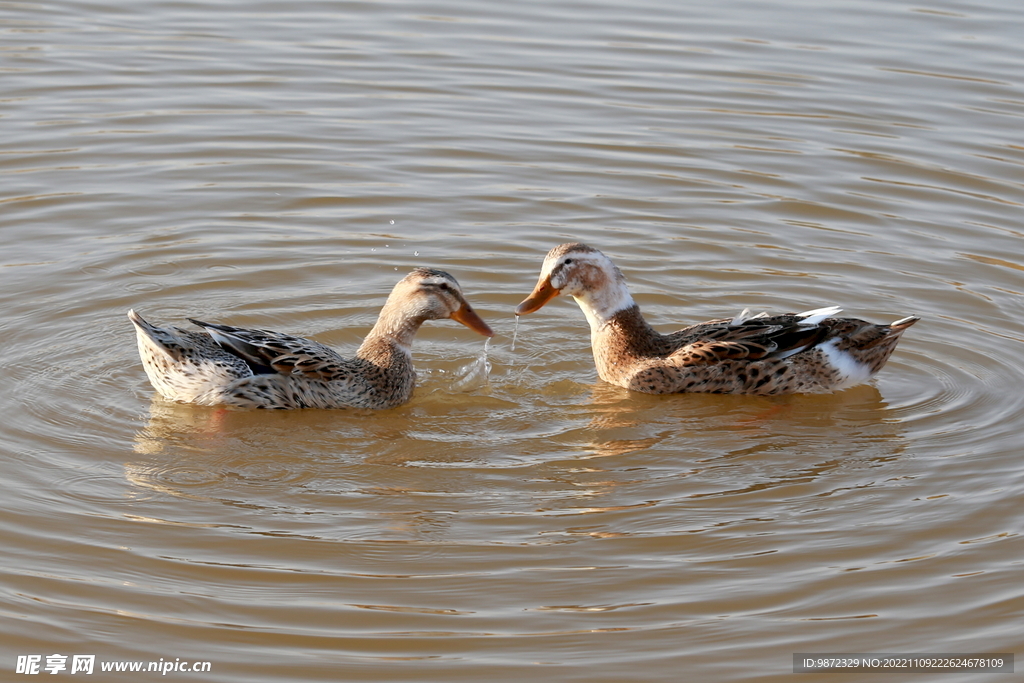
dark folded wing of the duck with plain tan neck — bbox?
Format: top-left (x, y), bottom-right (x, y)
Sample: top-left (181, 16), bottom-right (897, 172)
top-left (188, 318), bottom-right (349, 381)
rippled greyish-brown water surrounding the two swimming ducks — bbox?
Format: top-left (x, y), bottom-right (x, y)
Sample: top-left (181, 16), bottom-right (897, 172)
top-left (0, 0), bottom-right (1024, 683)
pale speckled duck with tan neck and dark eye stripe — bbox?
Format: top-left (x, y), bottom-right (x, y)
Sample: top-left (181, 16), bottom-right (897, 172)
top-left (128, 268), bottom-right (494, 409)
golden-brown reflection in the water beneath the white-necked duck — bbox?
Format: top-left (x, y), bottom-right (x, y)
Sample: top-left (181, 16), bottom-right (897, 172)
top-left (524, 382), bottom-right (906, 535)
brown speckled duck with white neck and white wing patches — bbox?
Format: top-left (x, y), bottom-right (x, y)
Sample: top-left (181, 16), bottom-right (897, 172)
top-left (515, 243), bottom-right (921, 395)
